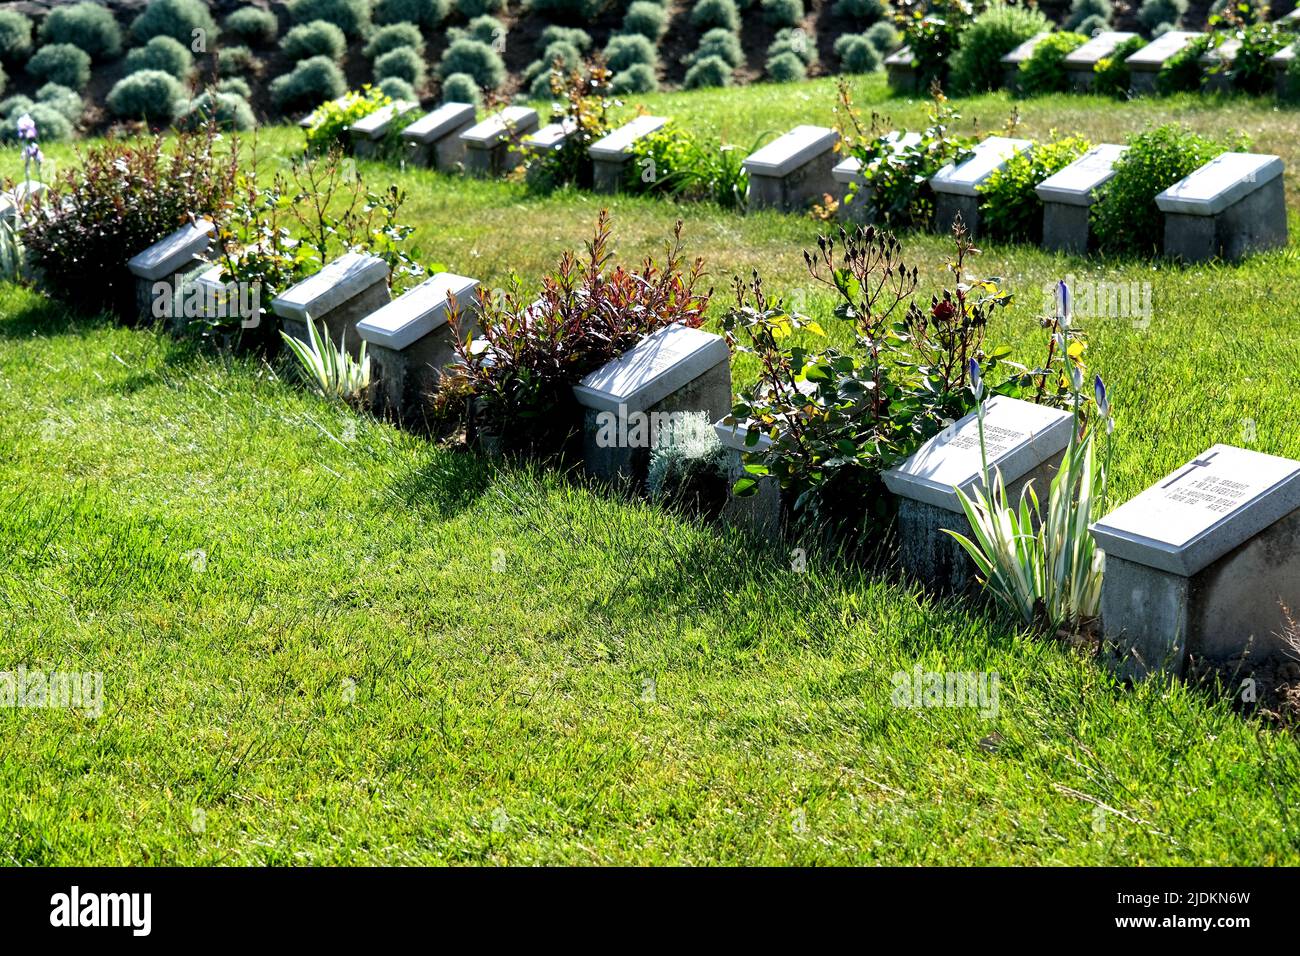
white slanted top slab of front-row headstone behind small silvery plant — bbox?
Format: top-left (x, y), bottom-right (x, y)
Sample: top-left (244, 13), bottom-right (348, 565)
top-left (573, 325), bottom-right (729, 412)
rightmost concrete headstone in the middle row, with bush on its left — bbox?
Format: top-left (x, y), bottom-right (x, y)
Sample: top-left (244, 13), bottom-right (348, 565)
top-left (1156, 152), bottom-right (1287, 263)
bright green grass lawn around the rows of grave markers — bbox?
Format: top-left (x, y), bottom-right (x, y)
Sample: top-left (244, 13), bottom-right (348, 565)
top-left (0, 81), bottom-right (1300, 864)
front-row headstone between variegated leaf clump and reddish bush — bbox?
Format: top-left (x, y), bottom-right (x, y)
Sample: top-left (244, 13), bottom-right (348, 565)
top-left (356, 272), bottom-right (478, 423)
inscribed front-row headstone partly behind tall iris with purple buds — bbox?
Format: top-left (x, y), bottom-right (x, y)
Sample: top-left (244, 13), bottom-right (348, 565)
top-left (883, 395), bottom-right (1074, 592)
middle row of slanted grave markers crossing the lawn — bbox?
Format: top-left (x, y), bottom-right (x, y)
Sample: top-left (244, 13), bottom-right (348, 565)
top-left (304, 98), bottom-right (1287, 263)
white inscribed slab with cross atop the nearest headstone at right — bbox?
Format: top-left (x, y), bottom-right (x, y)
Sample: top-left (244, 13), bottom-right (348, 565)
top-left (1092, 445), bottom-right (1300, 578)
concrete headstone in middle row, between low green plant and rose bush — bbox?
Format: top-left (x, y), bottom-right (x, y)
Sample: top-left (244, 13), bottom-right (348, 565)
top-left (744, 126), bottom-right (840, 212)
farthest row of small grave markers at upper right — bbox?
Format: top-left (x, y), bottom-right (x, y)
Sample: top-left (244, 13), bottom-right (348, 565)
top-left (885, 22), bottom-right (1300, 96)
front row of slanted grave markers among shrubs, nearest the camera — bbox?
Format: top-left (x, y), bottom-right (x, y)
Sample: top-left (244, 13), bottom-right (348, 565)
top-left (127, 215), bottom-right (1300, 676)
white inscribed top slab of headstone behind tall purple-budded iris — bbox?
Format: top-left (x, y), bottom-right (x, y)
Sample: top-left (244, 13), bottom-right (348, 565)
top-left (883, 395), bottom-right (1074, 514)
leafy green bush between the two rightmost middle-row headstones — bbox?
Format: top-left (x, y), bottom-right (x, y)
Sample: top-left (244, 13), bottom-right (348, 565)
top-left (1092, 124), bottom-right (1245, 255)
